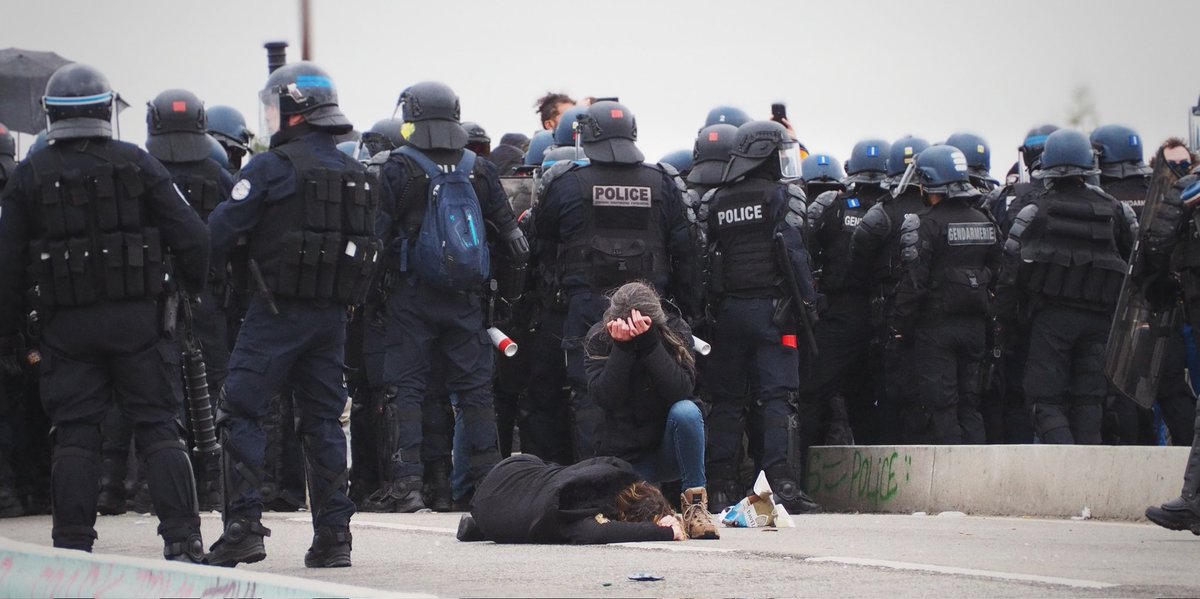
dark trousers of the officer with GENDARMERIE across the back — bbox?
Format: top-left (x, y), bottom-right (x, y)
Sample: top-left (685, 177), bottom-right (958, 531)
top-left (906, 316), bottom-right (986, 444)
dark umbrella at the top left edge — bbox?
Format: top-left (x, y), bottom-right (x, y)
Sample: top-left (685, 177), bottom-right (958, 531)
top-left (0, 48), bottom-right (70, 133)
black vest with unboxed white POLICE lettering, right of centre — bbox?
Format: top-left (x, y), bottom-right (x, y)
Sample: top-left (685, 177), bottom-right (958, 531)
top-left (708, 179), bottom-right (782, 295)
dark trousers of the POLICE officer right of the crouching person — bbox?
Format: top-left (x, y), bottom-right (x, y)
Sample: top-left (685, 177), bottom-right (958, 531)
top-left (704, 298), bottom-right (799, 480)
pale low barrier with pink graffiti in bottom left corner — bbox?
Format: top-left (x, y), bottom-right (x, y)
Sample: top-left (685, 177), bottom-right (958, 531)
top-left (0, 538), bottom-right (431, 599)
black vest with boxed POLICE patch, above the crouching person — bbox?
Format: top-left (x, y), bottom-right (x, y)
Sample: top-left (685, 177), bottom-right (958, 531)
top-left (559, 164), bottom-right (670, 292)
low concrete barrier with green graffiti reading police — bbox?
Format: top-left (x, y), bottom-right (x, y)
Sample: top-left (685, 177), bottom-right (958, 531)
top-left (806, 445), bottom-right (1188, 520)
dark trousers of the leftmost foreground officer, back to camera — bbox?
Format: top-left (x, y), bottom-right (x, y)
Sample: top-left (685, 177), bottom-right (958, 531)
top-left (41, 300), bottom-right (200, 550)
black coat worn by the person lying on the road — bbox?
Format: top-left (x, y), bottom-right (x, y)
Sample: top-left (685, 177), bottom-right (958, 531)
top-left (470, 455), bottom-right (673, 545)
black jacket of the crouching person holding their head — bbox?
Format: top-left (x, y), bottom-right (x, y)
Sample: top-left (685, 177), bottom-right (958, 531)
top-left (587, 317), bottom-right (696, 462)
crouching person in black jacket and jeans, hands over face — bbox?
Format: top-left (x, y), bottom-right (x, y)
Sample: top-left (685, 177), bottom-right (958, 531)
top-left (584, 282), bottom-right (718, 539)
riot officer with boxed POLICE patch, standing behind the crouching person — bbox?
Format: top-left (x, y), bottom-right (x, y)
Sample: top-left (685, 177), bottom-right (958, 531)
top-left (530, 101), bottom-right (700, 459)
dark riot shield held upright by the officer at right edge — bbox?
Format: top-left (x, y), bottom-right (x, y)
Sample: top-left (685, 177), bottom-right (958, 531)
top-left (1104, 160), bottom-right (1183, 408)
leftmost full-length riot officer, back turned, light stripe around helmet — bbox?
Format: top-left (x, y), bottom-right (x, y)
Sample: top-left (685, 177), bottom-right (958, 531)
top-left (0, 64), bottom-right (209, 562)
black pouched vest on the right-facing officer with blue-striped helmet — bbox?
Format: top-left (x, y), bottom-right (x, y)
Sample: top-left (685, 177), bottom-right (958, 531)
top-left (250, 142), bottom-right (382, 305)
